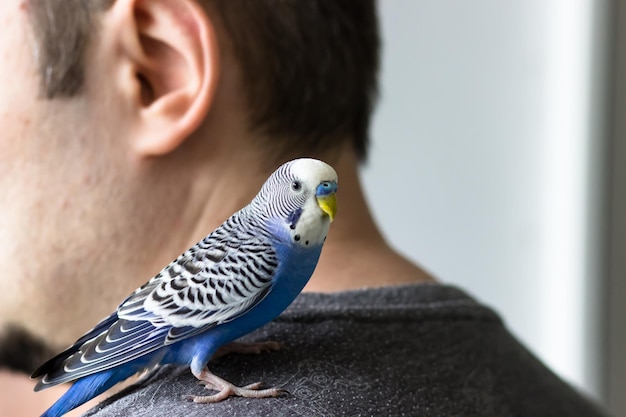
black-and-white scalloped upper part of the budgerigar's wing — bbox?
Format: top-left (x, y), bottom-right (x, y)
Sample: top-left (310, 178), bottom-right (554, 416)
top-left (118, 212), bottom-right (278, 343)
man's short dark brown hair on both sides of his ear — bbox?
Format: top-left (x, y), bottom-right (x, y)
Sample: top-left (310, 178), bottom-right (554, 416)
top-left (30, 0), bottom-right (380, 159)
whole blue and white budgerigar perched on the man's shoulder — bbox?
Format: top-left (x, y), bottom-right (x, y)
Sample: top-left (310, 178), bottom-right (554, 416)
top-left (32, 159), bottom-right (337, 417)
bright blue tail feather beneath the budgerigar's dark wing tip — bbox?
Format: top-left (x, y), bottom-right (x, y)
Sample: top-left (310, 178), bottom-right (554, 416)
top-left (41, 365), bottom-right (137, 417)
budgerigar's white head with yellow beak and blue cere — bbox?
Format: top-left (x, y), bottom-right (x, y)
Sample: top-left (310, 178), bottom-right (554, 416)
top-left (259, 158), bottom-right (337, 247)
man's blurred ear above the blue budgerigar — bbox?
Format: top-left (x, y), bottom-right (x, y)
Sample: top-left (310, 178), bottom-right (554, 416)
top-left (108, 0), bottom-right (219, 156)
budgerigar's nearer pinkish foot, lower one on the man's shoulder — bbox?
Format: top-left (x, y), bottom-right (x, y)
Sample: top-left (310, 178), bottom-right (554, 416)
top-left (184, 369), bottom-right (286, 403)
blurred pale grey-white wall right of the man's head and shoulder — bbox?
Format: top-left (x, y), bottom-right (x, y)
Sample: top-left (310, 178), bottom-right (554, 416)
top-left (363, 0), bottom-right (608, 404)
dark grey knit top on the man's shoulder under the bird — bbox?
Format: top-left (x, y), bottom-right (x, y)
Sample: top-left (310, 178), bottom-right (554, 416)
top-left (86, 284), bottom-right (603, 417)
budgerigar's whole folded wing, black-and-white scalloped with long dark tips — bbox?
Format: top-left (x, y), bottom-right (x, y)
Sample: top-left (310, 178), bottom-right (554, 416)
top-left (38, 223), bottom-right (278, 389)
